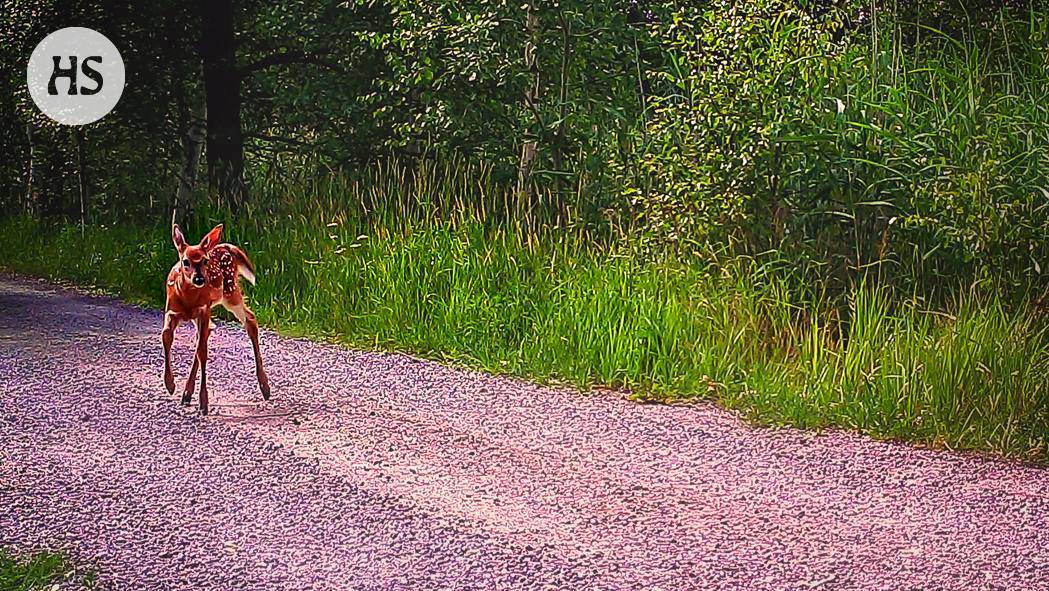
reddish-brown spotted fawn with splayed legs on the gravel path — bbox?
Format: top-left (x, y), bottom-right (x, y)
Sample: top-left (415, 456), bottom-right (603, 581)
top-left (162, 219), bottom-right (270, 416)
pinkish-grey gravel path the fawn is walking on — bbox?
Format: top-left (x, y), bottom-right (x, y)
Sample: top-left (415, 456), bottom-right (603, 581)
top-left (0, 277), bottom-right (1049, 591)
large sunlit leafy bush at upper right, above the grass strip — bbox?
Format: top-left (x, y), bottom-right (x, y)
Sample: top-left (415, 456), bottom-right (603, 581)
top-left (622, 0), bottom-right (1049, 293)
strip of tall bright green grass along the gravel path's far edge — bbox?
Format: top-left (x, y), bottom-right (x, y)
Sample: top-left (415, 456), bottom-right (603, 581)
top-left (0, 180), bottom-right (1049, 459)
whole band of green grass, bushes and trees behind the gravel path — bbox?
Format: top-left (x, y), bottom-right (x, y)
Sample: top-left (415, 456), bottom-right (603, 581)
top-left (0, 0), bottom-right (1049, 460)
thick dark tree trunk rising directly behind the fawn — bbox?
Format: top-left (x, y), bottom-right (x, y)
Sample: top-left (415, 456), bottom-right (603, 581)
top-left (197, 0), bottom-right (248, 209)
